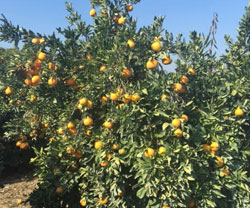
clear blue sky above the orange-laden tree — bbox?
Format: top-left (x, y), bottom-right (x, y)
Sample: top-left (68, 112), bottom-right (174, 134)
top-left (0, 0), bottom-right (248, 55)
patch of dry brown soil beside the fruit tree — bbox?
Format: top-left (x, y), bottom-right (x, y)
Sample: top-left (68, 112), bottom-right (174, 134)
top-left (0, 169), bottom-right (38, 208)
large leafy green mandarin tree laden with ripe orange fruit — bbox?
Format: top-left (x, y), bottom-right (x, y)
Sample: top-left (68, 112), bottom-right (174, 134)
top-left (0, 0), bottom-right (249, 208)
